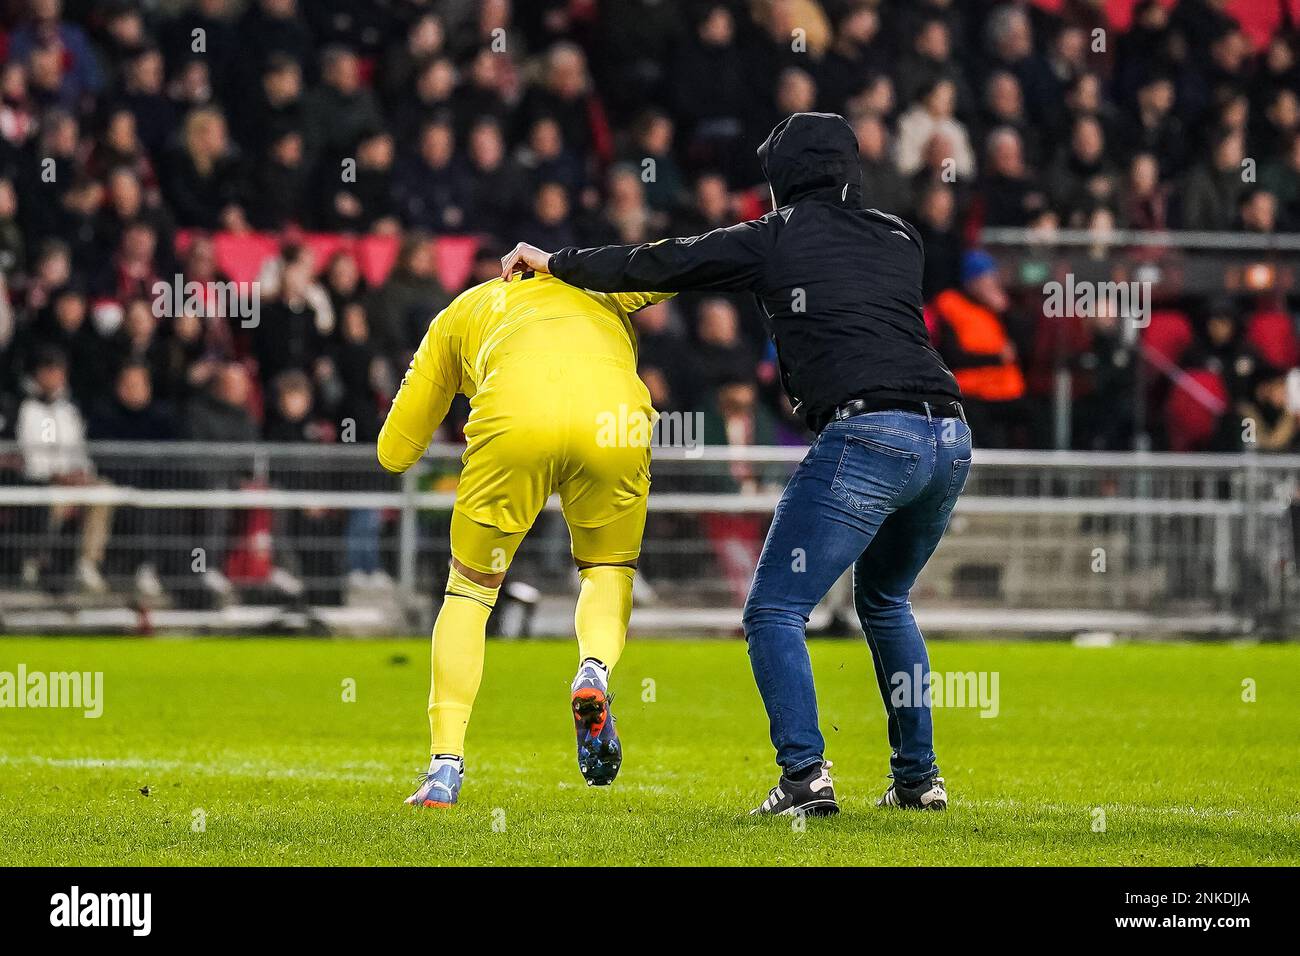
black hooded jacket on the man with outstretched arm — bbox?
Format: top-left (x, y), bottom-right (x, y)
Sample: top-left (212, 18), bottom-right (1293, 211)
top-left (550, 113), bottom-right (961, 423)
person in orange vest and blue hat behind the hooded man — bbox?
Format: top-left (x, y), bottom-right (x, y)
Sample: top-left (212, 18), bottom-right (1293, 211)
top-left (931, 251), bottom-right (1030, 447)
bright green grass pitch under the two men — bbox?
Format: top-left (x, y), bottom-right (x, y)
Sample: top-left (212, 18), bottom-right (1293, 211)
top-left (0, 639), bottom-right (1300, 865)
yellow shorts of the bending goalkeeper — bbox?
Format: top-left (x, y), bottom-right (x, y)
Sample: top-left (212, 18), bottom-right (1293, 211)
top-left (451, 351), bottom-right (654, 574)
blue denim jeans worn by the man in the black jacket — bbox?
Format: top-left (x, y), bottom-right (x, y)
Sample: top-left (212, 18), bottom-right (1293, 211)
top-left (744, 411), bottom-right (971, 784)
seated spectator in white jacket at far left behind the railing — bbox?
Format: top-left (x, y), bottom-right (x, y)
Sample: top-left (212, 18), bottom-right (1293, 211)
top-left (14, 347), bottom-right (113, 594)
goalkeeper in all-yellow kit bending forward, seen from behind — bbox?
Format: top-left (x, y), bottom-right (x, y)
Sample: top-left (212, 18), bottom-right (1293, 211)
top-left (378, 273), bottom-right (668, 806)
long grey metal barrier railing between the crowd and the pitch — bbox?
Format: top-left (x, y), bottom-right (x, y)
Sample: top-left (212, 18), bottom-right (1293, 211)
top-left (0, 442), bottom-right (1300, 633)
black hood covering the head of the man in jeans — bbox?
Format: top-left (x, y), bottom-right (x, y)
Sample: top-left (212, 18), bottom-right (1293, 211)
top-left (758, 113), bottom-right (862, 207)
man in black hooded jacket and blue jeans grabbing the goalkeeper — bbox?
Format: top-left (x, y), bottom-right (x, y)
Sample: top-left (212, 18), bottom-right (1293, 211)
top-left (502, 113), bottom-right (971, 814)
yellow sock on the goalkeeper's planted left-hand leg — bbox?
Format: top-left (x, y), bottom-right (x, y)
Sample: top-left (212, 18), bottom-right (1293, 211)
top-left (429, 568), bottom-right (499, 757)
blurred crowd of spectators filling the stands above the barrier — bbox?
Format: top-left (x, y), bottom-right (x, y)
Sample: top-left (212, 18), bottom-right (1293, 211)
top-left (0, 0), bottom-right (1300, 598)
